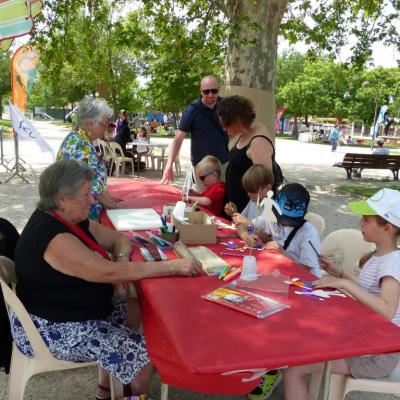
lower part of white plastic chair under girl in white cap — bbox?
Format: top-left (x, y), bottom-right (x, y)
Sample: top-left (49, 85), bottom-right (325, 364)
top-left (309, 363), bottom-right (400, 400)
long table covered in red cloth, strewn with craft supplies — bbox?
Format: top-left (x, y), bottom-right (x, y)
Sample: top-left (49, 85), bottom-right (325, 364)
top-left (105, 181), bottom-right (400, 394)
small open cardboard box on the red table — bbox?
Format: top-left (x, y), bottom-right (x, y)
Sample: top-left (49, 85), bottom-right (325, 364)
top-left (171, 211), bottom-right (217, 244)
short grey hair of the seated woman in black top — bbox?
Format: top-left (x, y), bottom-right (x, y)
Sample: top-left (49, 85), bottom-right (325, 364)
top-left (37, 158), bottom-right (93, 211)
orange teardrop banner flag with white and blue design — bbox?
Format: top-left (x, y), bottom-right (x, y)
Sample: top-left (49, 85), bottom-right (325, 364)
top-left (11, 46), bottom-right (39, 112)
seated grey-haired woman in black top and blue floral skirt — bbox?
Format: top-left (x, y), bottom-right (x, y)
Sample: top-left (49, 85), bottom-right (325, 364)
top-left (10, 159), bottom-right (202, 399)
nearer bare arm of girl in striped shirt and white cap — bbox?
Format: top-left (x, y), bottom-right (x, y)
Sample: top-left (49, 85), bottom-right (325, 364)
top-left (314, 276), bottom-right (400, 320)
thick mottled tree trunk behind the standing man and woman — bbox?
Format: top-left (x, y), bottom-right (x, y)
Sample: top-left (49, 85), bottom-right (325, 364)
top-left (225, 0), bottom-right (288, 133)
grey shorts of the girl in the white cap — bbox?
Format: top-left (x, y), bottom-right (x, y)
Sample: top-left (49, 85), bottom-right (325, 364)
top-left (345, 353), bottom-right (400, 379)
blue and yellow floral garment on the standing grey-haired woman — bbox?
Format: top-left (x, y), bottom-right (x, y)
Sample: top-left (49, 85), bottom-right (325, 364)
top-left (57, 131), bottom-right (107, 221)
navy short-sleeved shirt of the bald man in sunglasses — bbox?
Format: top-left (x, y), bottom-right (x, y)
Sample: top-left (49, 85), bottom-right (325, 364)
top-left (178, 97), bottom-right (228, 165)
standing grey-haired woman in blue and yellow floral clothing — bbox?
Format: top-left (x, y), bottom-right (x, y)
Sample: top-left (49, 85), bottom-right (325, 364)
top-left (57, 97), bottom-right (118, 221)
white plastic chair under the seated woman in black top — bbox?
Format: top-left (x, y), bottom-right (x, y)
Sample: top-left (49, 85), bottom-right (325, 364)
top-left (0, 257), bottom-right (96, 400)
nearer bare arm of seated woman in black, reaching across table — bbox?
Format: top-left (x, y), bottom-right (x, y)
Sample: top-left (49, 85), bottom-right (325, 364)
top-left (44, 233), bottom-right (202, 283)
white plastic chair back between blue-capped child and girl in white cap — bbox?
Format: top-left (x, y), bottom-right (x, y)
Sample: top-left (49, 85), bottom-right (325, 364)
top-left (320, 229), bottom-right (375, 274)
